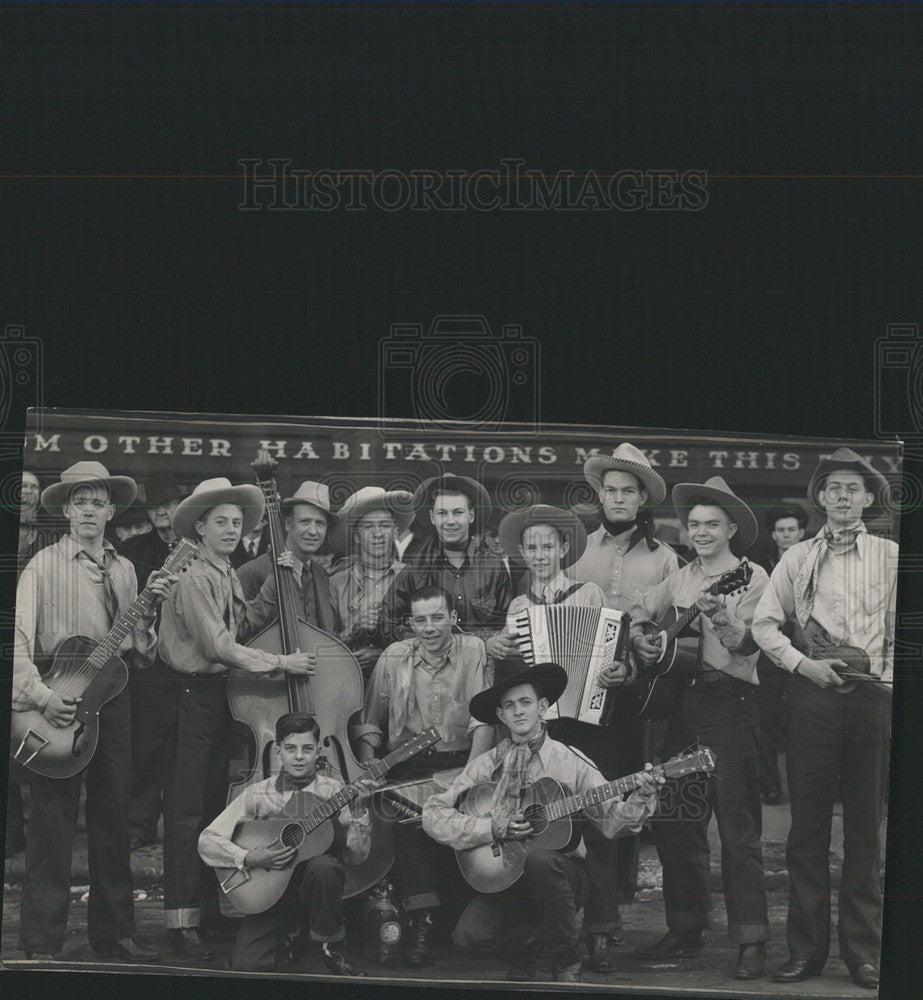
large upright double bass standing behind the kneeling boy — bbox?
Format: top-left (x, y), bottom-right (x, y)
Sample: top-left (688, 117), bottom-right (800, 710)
top-left (228, 450), bottom-right (394, 897)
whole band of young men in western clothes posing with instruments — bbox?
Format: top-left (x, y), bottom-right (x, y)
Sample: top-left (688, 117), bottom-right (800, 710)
top-left (13, 443), bottom-right (897, 989)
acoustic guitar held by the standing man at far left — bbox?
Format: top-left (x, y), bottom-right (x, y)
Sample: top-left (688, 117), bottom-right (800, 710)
top-left (10, 539), bottom-right (198, 778)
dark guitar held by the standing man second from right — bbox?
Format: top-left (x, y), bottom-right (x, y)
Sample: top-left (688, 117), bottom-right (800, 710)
top-left (624, 559), bottom-right (753, 719)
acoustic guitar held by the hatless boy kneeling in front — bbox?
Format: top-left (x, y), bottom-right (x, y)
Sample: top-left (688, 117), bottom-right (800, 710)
top-left (215, 726), bottom-right (442, 913)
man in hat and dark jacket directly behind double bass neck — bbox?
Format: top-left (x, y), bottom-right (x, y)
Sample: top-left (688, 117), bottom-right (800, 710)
top-left (237, 480), bottom-right (342, 637)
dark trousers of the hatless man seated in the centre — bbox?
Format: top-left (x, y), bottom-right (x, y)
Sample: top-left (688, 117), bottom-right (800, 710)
top-left (389, 751), bottom-right (468, 912)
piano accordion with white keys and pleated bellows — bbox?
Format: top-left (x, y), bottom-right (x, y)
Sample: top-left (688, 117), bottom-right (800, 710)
top-left (512, 604), bottom-right (631, 726)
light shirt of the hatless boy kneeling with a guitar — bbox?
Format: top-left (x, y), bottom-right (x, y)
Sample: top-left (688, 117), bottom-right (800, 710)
top-left (199, 773), bottom-right (372, 871)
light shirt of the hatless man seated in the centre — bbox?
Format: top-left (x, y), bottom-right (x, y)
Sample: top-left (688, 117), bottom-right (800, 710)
top-left (362, 634), bottom-right (490, 751)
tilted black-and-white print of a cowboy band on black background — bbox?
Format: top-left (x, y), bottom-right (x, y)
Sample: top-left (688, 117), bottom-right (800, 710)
top-left (3, 406), bottom-right (902, 997)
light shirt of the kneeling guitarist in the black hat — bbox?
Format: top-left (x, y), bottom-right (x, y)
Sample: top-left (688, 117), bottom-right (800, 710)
top-left (423, 737), bottom-right (657, 858)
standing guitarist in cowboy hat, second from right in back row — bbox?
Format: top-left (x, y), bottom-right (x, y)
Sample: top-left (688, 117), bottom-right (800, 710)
top-left (631, 476), bottom-right (769, 979)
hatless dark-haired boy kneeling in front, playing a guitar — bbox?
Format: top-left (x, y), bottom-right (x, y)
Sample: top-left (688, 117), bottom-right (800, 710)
top-left (199, 712), bottom-right (374, 976)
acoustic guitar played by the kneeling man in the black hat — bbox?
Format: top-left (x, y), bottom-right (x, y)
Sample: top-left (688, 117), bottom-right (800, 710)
top-left (455, 747), bottom-right (715, 893)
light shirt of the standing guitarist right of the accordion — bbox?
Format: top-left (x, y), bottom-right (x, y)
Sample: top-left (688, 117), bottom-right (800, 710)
top-left (630, 559), bottom-right (769, 684)
